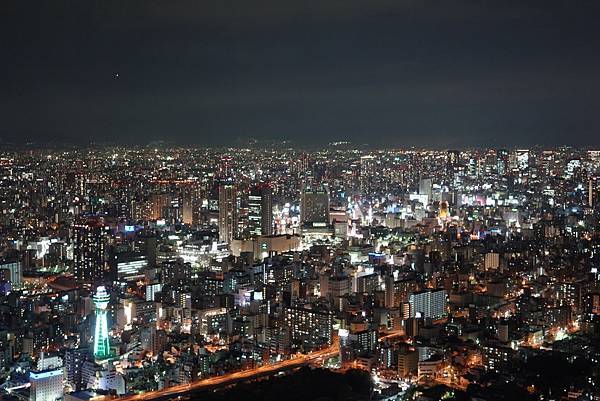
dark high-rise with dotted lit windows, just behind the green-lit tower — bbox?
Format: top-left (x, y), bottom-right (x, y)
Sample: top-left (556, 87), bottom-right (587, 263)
top-left (73, 220), bottom-right (107, 283)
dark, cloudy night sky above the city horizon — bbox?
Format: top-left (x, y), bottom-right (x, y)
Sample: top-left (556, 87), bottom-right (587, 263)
top-left (0, 0), bottom-right (600, 148)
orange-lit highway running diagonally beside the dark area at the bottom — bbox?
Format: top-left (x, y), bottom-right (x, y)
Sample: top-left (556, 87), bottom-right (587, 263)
top-left (114, 342), bottom-right (339, 401)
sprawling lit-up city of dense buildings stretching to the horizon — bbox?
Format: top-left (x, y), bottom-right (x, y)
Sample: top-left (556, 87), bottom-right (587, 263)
top-left (0, 147), bottom-right (600, 401)
